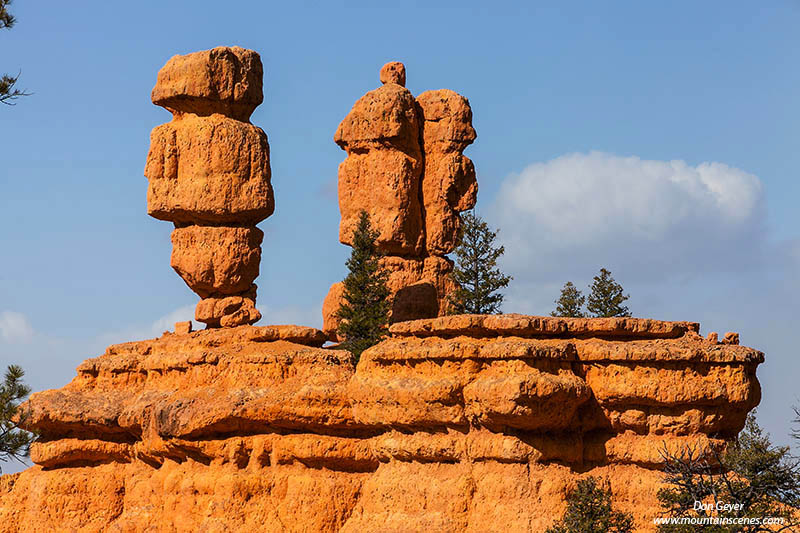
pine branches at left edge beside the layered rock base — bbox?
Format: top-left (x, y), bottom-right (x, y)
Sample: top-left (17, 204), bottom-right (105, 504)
top-left (0, 365), bottom-right (34, 468)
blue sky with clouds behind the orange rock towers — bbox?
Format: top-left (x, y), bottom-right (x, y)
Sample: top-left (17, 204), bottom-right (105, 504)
top-left (0, 1), bottom-right (800, 471)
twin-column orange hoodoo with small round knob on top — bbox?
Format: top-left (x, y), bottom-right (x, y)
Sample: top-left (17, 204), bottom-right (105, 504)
top-left (323, 62), bottom-right (478, 338)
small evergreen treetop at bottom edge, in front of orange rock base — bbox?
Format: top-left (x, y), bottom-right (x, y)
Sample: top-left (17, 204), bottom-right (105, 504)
top-left (546, 476), bottom-right (633, 533)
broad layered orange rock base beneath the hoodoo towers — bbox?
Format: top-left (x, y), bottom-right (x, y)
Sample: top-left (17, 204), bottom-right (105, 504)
top-left (0, 315), bottom-right (763, 533)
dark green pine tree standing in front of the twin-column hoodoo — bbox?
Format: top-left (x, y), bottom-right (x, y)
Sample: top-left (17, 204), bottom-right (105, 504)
top-left (336, 211), bottom-right (390, 362)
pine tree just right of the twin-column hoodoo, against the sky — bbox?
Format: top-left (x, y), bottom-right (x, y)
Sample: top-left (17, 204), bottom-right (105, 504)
top-left (448, 212), bottom-right (512, 315)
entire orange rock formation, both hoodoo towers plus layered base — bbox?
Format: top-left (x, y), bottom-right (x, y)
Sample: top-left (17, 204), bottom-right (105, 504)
top-left (0, 54), bottom-right (764, 533)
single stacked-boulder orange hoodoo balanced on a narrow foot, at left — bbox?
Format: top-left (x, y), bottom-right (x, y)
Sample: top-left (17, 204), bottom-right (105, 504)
top-left (145, 47), bottom-right (275, 327)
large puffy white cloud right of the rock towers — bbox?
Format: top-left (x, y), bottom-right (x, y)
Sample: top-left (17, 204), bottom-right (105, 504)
top-left (488, 152), bottom-right (764, 282)
